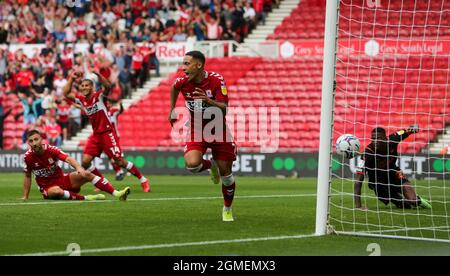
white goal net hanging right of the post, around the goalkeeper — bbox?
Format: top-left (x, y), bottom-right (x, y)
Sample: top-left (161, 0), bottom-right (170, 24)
top-left (321, 0), bottom-right (450, 241)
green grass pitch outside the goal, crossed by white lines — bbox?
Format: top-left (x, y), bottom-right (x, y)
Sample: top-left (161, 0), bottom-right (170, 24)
top-left (0, 173), bottom-right (450, 256)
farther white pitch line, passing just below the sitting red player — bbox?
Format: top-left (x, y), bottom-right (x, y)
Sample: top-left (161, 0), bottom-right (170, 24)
top-left (0, 194), bottom-right (316, 206)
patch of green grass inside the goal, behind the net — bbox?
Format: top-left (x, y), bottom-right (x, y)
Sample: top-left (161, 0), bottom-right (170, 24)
top-left (330, 180), bottom-right (450, 240)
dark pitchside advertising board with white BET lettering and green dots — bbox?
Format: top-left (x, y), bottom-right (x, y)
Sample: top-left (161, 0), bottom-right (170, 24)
top-left (0, 151), bottom-right (450, 179)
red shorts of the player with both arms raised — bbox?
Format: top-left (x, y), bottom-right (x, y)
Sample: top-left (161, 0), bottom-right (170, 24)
top-left (84, 131), bottom-right (123, 159)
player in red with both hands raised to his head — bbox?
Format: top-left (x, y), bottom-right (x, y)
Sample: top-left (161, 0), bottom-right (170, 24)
top-left (63, 71), bottom-right (150, 192)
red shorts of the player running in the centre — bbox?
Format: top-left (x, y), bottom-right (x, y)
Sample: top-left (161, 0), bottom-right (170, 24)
top-left (184, 142), bottom-right (237, 161)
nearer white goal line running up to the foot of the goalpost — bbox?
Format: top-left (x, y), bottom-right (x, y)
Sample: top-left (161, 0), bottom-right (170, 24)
top-left (6, 234), bottom-right (315, 256)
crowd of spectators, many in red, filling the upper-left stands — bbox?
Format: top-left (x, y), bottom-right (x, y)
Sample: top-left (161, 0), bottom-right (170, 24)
top-left (0, 0), bottom-right (279, 148)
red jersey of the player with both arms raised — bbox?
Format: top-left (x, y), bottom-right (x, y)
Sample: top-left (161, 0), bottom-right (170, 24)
top-left (75, 90), bottom-right (113, 134)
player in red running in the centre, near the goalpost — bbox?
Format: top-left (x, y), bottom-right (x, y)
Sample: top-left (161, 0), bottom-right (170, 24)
top-left (169, 51), bottom-right (236, 221)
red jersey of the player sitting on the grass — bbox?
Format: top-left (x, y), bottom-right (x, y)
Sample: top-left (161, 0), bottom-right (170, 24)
top-left (23, 144), bottom-right (68, 188)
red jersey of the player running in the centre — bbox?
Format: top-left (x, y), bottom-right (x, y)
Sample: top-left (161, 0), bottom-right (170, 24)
top-left (174, 71), bottom-right (229, 141)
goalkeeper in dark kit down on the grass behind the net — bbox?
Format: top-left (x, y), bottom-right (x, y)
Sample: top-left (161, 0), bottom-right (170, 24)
top-left (354, 125), bottom-right (431, 209)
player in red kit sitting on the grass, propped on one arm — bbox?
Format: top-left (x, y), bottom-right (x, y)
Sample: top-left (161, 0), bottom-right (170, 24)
top-left (22, 130), bottom-right (130, 200)
